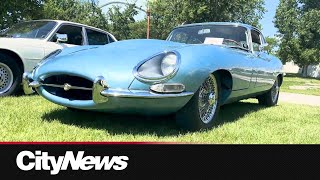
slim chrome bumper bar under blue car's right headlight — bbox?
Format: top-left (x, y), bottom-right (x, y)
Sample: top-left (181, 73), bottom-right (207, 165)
top-left (101, 89), bottom-right (194, 99)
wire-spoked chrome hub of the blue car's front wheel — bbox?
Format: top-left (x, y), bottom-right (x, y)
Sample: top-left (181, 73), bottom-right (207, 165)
top-left (199, 75), bottom-right (218, 124)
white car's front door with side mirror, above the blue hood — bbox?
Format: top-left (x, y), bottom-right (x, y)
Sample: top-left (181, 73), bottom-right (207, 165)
top-left (45, 24), bottom-right (85, 56)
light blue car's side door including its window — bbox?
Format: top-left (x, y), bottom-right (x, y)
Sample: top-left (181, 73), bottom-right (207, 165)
top-left (251, 29), bottom-right (274, 87)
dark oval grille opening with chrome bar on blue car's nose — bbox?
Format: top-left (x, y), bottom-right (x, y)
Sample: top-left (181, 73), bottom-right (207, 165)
top-left (43, 75), bottom-right (93, 100)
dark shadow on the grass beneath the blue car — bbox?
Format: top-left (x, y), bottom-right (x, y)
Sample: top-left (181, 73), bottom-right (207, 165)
top-left (42, 102), bottom-right (264, 136)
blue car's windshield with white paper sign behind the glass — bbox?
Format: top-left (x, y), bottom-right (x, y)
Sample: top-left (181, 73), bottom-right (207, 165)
top-left (167, 25), bottom-right (248, 50)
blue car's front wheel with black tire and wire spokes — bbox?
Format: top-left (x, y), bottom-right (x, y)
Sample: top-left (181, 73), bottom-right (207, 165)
top-left (176, 74), bottom-right (221, 131)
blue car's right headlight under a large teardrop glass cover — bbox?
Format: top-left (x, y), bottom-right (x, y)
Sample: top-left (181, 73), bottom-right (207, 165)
top-left (134, 51), bottom-right (180, 82)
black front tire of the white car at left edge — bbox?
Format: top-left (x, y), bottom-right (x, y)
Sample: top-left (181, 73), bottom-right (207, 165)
top-left (0, 53), bottom-right (22, 97)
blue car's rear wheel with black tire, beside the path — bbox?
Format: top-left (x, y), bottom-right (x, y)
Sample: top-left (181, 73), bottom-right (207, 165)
top-left (257, 78), bottom-right (280, 107)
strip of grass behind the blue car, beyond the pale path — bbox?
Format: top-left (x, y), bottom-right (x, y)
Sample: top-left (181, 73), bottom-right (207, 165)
top-left (281, 74), bottom-right (320, 96)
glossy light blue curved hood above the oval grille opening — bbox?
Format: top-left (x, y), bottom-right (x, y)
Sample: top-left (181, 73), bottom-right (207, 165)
top-left (35, 39), bottom-right (188, 88)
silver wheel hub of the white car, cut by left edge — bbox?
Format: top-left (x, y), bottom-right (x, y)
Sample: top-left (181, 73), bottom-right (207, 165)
top-left (0, 63), bottom-right (13, 94)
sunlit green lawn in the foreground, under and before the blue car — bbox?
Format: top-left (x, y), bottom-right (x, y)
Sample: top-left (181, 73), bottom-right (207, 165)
top-left (0, 96), bottom-right (320, 144)
